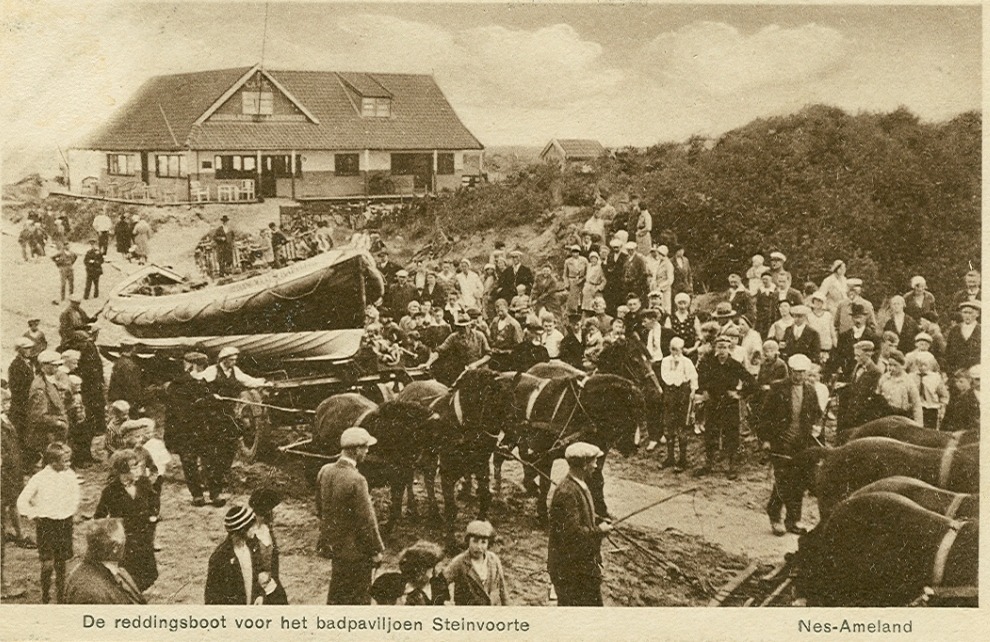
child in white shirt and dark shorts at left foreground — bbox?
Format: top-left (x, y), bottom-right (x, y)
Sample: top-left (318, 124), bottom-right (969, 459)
top-left (17, 441), bottom-right (79, 604)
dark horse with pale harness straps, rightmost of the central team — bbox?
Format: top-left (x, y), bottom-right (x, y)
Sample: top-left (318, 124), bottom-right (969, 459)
top-left (496, 374), bottom-right (643, 524)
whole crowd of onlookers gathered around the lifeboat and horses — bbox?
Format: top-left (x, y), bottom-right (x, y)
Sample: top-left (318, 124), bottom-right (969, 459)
top-left (0, 192), bottom-right (982, 605)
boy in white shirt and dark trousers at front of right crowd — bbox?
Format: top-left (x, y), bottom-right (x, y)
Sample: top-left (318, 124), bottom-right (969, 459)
top-left (660, 337), bottom-right (698, 473)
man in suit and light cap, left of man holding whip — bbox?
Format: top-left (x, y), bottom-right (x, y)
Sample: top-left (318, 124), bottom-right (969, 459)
top-left (316, 427), bottom-right (385, 604)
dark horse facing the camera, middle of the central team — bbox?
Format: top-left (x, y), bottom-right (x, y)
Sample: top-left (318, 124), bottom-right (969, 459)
top-left (398, 368), bottom-right (502, 535)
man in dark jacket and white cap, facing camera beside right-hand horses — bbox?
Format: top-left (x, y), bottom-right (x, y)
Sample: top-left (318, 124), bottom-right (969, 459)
top-left (757, 354), bottom-right (822, 535)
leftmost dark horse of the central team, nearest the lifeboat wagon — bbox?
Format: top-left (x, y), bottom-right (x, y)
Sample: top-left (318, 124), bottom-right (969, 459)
top-left (313, 392), bottom-right (436, 532)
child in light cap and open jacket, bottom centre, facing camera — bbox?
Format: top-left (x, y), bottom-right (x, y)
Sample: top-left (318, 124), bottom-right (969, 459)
top-left (443, 520), bottom-right (508, 606)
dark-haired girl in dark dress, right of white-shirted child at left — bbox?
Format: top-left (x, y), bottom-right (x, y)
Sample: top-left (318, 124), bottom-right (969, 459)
top-left (93, 449), bottom-right (161, 591)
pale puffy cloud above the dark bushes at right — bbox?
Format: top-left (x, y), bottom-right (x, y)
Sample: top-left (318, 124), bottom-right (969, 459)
top-left (642, 22), bottom-right (847, 95)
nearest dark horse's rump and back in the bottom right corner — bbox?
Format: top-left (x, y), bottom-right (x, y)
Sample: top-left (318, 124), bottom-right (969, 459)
top-left (794, 492), bottom-right (979, 607)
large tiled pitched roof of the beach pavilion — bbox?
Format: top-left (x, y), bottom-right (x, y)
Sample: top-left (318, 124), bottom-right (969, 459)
top-left (83, 67), bottom-right (483, 151)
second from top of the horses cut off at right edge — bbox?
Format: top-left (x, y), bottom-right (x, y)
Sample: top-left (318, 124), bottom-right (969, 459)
top-left (794, 437), bottom-right (980, 519)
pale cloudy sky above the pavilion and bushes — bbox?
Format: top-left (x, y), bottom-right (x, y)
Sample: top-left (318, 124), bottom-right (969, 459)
top-left (0, 0), bottom-right (982, 182)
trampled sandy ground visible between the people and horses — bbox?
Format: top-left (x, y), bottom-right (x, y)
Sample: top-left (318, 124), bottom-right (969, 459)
top-left (0, 202), bottom-right (817, 605)
